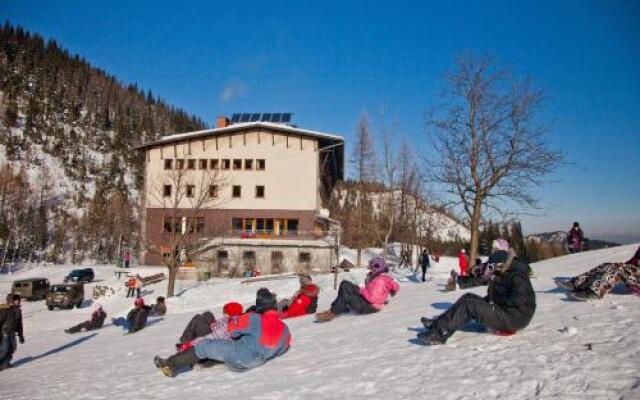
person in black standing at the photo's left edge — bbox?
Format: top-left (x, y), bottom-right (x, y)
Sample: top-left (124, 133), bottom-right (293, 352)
top-left (0, 294), bottom-right (24, 371)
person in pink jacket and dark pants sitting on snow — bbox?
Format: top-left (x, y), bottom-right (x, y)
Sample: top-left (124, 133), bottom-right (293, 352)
top-left (316, 258), bottom-right (400, 322)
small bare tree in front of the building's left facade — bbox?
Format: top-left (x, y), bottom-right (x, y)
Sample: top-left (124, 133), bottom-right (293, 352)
top-left (149, 168), bottom-right (228, 297)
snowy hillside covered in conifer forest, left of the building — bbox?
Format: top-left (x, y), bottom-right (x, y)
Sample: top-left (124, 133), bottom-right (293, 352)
top-left (0, 23), bottom-right (204, 262)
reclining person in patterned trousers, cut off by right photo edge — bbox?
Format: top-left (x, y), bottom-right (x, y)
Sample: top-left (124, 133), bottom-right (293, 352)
top-left (554, 247), bottom-right (640, 300)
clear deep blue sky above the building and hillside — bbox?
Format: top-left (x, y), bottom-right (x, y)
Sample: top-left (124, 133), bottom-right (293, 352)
top-left (0, 0), bottom-right (640, 241)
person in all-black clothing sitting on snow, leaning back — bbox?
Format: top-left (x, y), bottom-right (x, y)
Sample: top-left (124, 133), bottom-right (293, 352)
top-left (418, 249), bottom-right (536, 345)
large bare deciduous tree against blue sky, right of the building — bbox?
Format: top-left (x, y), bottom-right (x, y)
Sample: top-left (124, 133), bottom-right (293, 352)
top-left (428, 54), bottom-right (563, 260)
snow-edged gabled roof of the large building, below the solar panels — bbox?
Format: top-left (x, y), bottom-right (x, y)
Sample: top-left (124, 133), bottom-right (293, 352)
top-left (136, 122), bottom-right (344, 149)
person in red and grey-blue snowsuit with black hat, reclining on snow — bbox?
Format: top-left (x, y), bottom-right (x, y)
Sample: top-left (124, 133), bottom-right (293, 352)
top-left (154, 288), bottom-right (291, 377)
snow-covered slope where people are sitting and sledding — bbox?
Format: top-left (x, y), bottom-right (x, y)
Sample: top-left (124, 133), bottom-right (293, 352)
top-left (0, 245), bottom-right (640, 400)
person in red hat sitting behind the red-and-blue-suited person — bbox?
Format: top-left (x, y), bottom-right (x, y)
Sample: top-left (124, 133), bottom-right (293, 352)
top-left (176, 302), bottom-right (242, 351)
